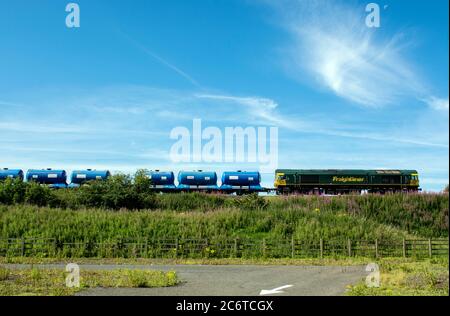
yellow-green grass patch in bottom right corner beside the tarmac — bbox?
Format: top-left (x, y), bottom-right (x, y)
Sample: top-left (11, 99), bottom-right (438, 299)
top-left (347, 258), bottom-right (449, 296)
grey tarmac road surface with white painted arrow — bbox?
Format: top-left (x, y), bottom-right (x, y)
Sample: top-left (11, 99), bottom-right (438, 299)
top-left (3, 265), bottom-right (367, 296)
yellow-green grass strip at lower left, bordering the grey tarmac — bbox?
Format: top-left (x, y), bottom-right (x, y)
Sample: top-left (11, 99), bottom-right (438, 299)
top-left (0, 267), bottom-right (178, 296)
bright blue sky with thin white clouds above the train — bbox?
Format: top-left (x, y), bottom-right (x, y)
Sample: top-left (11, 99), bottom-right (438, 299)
top-left (0, 0), bottom-right (449, 191)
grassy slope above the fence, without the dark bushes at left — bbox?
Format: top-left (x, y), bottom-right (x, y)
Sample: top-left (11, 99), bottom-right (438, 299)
top-left (0, 191), bottom-right (449, 241)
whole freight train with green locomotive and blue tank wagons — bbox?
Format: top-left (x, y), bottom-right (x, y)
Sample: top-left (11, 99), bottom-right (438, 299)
top-left (0, 168), bottom-right (420, 195)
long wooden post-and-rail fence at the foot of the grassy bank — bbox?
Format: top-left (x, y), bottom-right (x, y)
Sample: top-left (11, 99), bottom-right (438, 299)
top-left (0, 238), bottom-right (449, 258)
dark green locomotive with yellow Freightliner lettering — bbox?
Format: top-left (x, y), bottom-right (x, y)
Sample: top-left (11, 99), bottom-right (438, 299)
top-left (274, 169), bottom-right (419, 194)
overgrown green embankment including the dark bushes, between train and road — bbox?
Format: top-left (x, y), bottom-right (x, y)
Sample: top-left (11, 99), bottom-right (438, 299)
top-left (0, 185), bottom-right (449, 258)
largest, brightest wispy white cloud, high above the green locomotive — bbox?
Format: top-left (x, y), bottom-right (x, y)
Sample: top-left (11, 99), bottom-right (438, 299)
top-left (270, 0), bottom-right (424, 107)
